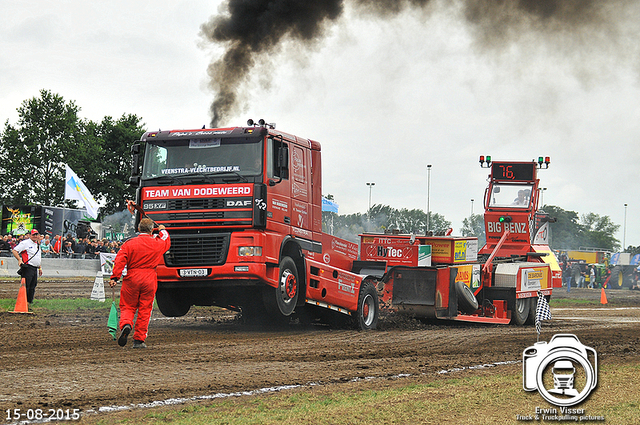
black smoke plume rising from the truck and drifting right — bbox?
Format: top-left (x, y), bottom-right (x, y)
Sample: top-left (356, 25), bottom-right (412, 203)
top-left (201, 0), bottom-right (634, 127)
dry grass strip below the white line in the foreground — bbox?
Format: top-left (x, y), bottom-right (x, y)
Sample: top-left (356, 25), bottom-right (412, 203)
top-left (83, 364), bottom-right (640, 425)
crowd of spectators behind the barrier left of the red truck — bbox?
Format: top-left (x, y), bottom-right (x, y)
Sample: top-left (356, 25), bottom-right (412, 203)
top-left (0, 234), bottom-right (122, 259)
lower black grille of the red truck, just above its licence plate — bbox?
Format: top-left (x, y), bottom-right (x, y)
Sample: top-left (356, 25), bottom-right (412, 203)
top-left (164, 233), bottom-right (231, 267)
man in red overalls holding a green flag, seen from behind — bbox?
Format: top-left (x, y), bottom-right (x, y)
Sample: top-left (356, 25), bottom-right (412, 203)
top-left (109, 218), bottom-right (171, 348)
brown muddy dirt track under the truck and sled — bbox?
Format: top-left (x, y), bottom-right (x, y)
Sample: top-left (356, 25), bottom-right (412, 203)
top-left (0, 279), bottom-right (640, 423)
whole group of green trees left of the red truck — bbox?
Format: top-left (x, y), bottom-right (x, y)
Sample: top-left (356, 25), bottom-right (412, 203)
top-left (0, 90), bottom-right (145, 218)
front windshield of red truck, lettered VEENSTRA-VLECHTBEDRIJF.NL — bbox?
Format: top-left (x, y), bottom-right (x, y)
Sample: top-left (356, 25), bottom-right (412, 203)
top-left (142, 137), bottom-right (262, 180)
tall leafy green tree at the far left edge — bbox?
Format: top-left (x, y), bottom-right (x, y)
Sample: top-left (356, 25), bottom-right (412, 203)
top-left (0, 90), bottom-right (87, 205)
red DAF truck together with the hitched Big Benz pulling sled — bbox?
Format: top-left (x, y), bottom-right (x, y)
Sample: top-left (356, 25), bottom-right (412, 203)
top-left (131, 120), bottom-right (559, 329)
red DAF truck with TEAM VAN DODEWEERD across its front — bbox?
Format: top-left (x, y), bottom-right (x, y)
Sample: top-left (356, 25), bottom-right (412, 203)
top-left (131, 122), bottom-right (378, 329)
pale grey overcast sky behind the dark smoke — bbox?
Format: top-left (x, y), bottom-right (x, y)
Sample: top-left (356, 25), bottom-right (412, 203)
top-left (0, 0), bottom-right (640, 246)
